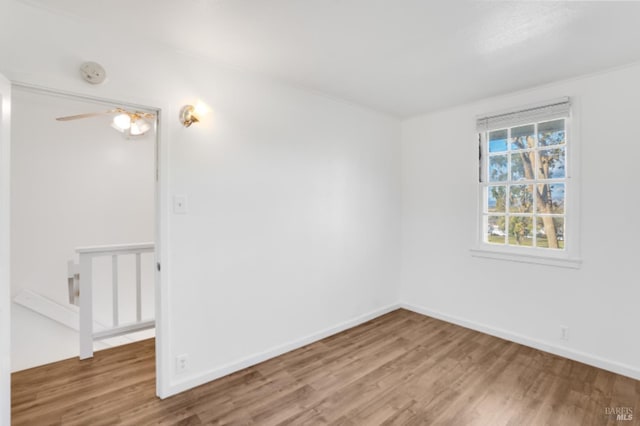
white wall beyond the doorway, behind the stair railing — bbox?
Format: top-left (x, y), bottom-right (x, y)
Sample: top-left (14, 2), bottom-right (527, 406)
top-left (11, 89), bottom-right (155, 371)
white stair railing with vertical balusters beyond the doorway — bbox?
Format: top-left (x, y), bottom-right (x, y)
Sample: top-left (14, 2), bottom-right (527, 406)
top-left (67, 243), bottom-right (155, 359)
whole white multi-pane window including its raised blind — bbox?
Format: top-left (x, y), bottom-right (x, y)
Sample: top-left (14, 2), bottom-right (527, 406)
top-left (477, 98), bottom-right (577, 266)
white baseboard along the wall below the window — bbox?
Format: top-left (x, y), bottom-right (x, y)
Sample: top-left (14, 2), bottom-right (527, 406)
top-left (399, 302), bottom-right (640, 380)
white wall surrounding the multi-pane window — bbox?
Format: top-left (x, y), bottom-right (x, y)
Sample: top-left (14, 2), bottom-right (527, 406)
top-left (401, 60), bottom-right (640, 378)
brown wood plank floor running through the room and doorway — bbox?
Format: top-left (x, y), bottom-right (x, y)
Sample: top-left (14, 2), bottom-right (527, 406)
top-left (12, 310), bottom-right (640, 426)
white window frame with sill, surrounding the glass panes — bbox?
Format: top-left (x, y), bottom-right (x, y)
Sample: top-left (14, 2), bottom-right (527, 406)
top-left (471, 98), bottom-right (582, 269)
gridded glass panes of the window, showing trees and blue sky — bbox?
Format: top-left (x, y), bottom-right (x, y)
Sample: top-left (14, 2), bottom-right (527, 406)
top-left (481, 112), bottom-right (567, 250)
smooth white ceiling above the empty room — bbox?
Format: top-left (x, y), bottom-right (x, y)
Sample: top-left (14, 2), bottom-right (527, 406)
top-left (22, 0), bottom-right (640, 117)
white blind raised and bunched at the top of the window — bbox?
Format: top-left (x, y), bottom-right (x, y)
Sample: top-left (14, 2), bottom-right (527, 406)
top-left (476, 98), bottom-right (571, 132)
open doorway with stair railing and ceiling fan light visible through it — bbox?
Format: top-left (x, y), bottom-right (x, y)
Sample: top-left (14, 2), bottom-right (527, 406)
top-left (10, 84), bottom-right (159, 372)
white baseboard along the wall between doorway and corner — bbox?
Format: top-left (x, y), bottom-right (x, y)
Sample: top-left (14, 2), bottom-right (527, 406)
top-left (168, 303), bottom-right (400, 398)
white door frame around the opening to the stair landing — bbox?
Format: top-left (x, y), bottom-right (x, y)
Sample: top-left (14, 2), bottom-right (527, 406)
top-left (5, 81), bottom-right (170, 402)
